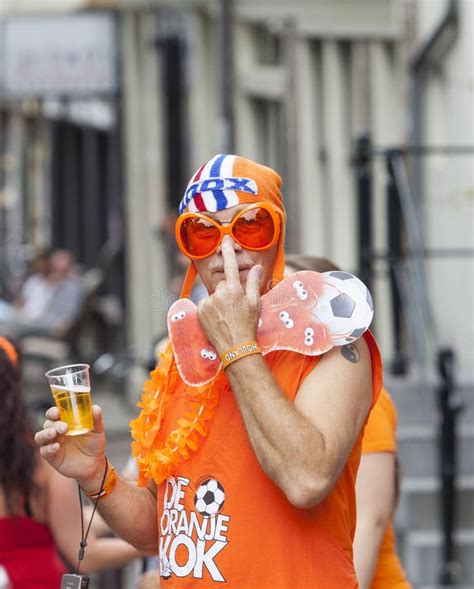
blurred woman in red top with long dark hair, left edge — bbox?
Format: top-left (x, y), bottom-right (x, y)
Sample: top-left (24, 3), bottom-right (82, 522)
top-left (0, 336), bottom-right (139, 589)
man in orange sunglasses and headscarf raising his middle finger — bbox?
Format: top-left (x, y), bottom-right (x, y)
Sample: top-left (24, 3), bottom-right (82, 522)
top-left (36, 155), bottom-right (381, 589)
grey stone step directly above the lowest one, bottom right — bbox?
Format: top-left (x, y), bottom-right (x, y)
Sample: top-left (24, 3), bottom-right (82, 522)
top-left (395, 476), bottom-right (474, 531)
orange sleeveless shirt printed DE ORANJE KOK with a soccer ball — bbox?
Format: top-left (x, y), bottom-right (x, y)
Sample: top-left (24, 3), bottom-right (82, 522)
top-left (157, 333), bottom-right (382, 589)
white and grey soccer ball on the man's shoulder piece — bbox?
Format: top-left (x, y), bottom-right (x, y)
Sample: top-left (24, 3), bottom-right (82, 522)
top-left (312, 271), bottom-right (374, 346)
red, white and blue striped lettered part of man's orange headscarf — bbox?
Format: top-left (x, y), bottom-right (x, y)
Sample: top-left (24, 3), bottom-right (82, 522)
top-left (179, 154), bottom-right (258, 214)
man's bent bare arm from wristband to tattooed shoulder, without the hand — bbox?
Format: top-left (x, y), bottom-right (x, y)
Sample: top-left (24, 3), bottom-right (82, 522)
top-left (227, 340), bottom-right (372, 508)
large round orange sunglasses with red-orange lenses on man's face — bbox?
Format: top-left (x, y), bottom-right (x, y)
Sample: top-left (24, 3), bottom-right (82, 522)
top-left (175, 202), bottom-right (281, 260)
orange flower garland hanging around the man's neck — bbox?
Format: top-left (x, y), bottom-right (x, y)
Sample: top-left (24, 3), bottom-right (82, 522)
top-left (130, 344), bottom-right (227, 486)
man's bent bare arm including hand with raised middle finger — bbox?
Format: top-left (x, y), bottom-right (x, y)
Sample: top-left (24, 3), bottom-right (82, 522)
top-left (198, 236), bottom-right (372, 507)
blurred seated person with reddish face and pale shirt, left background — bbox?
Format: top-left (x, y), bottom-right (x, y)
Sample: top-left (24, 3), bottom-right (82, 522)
top-left (0, 250), bottom-right (84, 338)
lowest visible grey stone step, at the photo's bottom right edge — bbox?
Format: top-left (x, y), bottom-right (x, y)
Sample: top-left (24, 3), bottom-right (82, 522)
top-left (403, 530), bottom-right (474, 589)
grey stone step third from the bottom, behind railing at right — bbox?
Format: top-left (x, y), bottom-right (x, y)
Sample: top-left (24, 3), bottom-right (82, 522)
top-left (397, 423), bottom-right (474, 477)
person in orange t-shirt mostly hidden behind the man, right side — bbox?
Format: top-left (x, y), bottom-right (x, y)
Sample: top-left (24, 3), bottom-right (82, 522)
top-left (285, 254), bottom-right (411, 589)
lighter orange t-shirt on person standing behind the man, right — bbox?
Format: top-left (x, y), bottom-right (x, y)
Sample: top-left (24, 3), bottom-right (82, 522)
top-left (362, 388), bottom-right (411, 589)
